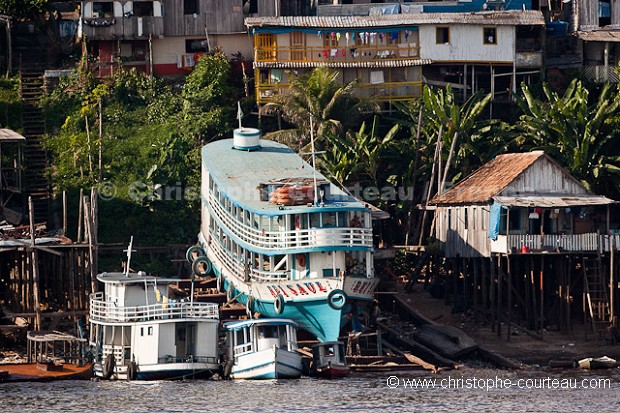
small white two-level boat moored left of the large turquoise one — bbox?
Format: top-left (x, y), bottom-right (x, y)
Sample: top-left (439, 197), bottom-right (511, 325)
top-left (90, 243), bottom-right (220, 380)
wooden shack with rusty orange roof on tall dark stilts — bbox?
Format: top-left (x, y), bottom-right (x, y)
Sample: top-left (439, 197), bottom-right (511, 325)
top-left (429, 151), bottom-right (620, 340)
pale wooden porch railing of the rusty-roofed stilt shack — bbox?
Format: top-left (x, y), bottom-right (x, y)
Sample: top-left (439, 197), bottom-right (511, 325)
top-left (491, 233), bottom-right (620, 254)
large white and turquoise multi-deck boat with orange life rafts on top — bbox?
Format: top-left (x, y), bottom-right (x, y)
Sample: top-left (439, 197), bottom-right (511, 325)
top-left (187, 128), bottom-right (378, 341)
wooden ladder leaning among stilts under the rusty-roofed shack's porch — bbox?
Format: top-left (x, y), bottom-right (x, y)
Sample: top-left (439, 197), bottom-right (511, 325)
top-left (582, 254), bottom-right (611, 338)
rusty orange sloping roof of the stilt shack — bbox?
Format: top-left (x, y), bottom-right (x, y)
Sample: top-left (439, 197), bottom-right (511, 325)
top-left (430, 151), bottom-right (546, 205)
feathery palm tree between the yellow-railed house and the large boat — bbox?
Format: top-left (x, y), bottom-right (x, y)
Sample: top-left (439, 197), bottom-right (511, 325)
top-left (263, 67), bottom-right (376, 146)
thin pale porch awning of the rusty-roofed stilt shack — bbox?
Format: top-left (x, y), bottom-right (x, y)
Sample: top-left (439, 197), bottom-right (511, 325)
top-left (493, 195), bottom-right (616, 208)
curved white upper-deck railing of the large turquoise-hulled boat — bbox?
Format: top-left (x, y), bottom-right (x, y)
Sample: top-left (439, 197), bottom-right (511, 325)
top-left (208, 191), bottom-right (372, 252)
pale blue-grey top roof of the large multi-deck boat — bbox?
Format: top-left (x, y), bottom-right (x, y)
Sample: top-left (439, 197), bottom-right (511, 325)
top-left (202, 139), bottom-right (369, 216)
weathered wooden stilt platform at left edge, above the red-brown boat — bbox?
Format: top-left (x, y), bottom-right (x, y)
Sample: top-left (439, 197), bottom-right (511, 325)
top-left (0, 189), bottom-right (97, 338)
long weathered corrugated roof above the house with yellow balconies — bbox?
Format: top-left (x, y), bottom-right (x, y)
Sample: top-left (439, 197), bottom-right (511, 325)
top-left (245, 10), bottom-right (545, 29)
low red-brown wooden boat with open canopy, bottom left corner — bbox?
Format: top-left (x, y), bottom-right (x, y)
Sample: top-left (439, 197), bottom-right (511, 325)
top-left (0, 331), bottom-right (93, 382)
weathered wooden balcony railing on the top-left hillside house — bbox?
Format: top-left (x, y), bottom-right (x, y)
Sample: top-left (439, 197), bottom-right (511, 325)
top-left (83, 16), bottom-right (164, 40)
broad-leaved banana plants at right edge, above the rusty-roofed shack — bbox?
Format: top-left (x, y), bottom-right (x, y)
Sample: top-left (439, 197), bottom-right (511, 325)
top-left (517, 79), bottom-right (620, 196)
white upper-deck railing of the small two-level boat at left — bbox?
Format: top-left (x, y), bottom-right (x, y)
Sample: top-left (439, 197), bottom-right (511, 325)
top-left (90, 292), bottom-right (219, 322)
